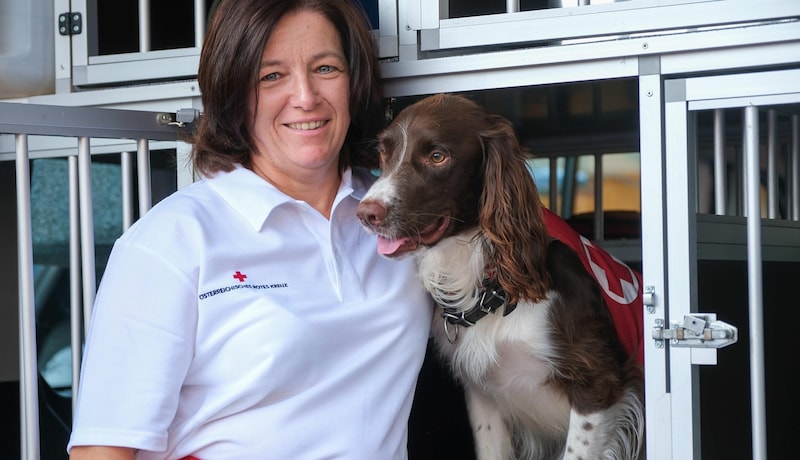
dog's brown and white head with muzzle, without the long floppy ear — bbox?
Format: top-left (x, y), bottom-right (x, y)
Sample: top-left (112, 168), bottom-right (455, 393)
top-left (358, 95), bottom-right (489, 257)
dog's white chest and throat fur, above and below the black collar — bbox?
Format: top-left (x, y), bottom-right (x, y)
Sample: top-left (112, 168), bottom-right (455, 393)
top-left (418, 236), bottom-right (570, 437)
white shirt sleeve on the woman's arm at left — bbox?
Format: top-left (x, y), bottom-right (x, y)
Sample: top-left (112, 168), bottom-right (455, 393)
top-left (68, 240), bottom-right (197, 451)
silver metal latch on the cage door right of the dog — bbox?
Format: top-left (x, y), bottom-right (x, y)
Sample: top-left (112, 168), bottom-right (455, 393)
top-left (653, 313), bottom-right (739, 348)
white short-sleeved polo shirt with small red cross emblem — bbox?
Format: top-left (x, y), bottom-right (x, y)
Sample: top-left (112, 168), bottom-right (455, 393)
top-left (70, 167), bottom-right (432, 460)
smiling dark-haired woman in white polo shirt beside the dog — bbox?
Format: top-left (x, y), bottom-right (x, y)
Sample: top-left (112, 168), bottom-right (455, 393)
top-left (68, 0), bottom-right (431, 459)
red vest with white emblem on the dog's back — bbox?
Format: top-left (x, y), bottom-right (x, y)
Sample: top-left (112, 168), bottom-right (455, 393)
top-left (542, 208), bottom-right (644, 364)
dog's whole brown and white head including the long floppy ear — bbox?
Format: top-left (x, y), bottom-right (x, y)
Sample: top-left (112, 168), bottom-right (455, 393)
top-left (357, 94), bottom-right (548, 299)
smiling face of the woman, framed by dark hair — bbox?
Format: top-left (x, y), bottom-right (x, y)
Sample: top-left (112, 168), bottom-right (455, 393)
top-left (251, 11), bottom-right (350, 187)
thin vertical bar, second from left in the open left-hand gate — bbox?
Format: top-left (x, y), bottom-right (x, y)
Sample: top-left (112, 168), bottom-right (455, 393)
top-left (67, 156), bottom-right (83, 414)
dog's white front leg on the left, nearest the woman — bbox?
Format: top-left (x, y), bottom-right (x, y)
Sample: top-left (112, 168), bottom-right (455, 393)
top-left (465, 388), bottom-right (513, 460)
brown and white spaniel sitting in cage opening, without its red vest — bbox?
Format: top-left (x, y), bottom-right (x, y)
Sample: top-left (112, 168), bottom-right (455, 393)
top-left (358, 95), bottom-right (644, 460)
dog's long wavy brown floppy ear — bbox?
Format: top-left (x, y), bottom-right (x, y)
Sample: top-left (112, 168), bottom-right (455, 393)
top-left (479, 115), bottom-right (550, 304)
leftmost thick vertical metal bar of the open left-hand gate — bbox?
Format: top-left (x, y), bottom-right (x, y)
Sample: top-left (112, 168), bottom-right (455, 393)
top-left (15, 134), bottom-right (39, 460)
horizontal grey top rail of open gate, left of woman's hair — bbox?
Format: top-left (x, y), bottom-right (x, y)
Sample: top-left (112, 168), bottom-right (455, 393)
top-left (0, 102), bottom-right (179, 141)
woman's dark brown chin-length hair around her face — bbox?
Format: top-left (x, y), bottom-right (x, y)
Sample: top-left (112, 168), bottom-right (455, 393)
top-left (191, 0), bottom-right (384, 174)
